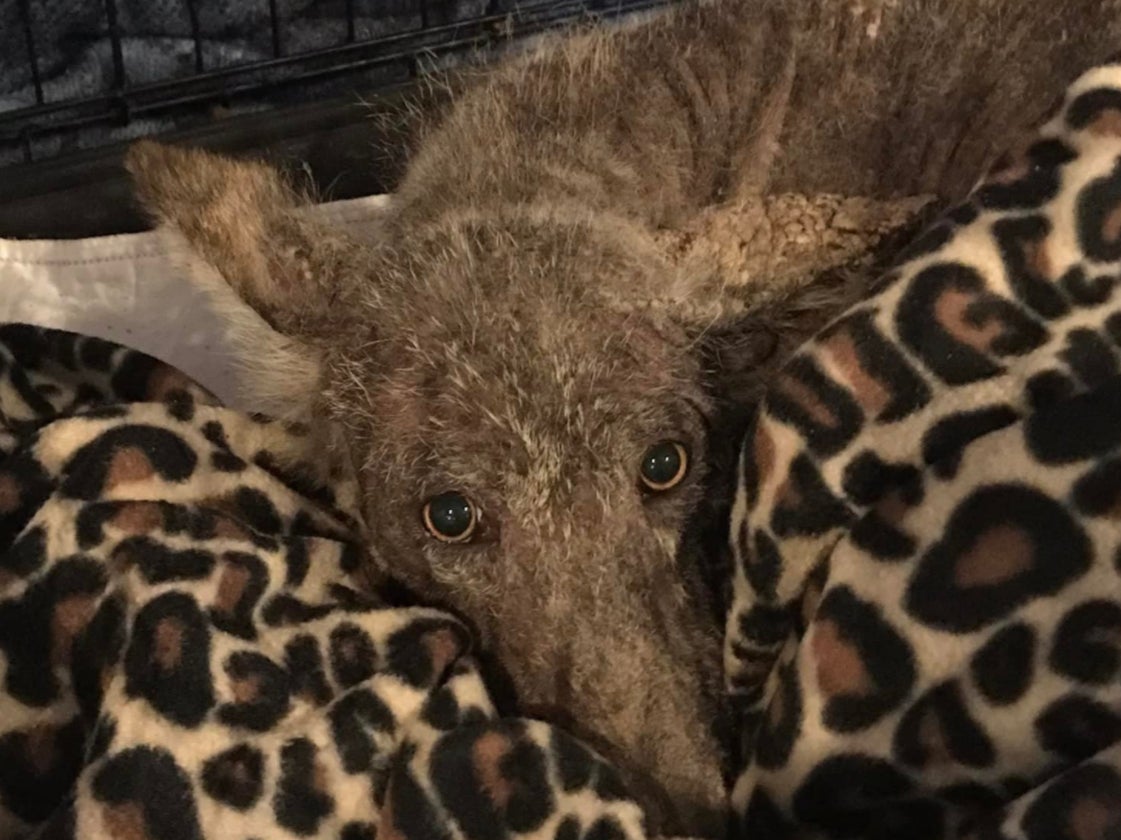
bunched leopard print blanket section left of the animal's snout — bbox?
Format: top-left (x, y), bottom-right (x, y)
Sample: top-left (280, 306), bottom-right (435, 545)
top-left (0, 325), bottom-right (642, 840)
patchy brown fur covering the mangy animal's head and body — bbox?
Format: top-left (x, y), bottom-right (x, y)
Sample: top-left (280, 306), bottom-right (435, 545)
top-left (129, 0), bottom-right (1121, 831)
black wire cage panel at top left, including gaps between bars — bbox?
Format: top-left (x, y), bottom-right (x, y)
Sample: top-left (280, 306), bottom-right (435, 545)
top-left (0, 0), bottom-right (667, 171)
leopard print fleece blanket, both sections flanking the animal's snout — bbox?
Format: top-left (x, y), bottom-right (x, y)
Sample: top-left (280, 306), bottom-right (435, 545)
top-left (0, 64), bottom-right (1121, 840)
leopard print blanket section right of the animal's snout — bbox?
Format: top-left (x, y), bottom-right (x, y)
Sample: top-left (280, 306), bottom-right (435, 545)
top-left (725, 64), bottom-right (1121, 840)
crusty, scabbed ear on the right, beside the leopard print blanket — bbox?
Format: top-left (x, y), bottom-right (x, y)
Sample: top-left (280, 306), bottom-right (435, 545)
top-left (661, 194), bottom-right (938, 403)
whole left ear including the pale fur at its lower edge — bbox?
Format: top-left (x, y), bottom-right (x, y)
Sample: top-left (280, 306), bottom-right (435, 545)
top-left (126, 140), bottom-right (360, 422)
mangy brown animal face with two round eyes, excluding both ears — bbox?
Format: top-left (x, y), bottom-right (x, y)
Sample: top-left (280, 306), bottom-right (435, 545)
top-left (324, 214), bottom-right (722, 834)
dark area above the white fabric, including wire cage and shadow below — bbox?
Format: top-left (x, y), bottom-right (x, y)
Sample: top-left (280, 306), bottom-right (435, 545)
top-left (0, 0), bottom-right (668, 239)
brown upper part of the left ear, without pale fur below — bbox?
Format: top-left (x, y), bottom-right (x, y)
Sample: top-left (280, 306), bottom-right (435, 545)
top-left (126, 140), bottom-right (358, 343)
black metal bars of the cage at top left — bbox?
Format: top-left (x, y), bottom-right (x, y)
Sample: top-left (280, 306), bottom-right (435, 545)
top-left (0, 0), bottom-right (670, 168)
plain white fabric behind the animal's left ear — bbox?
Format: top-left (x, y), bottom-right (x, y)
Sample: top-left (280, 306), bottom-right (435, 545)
top-left (0, 195), bottom-right (387, 410)
